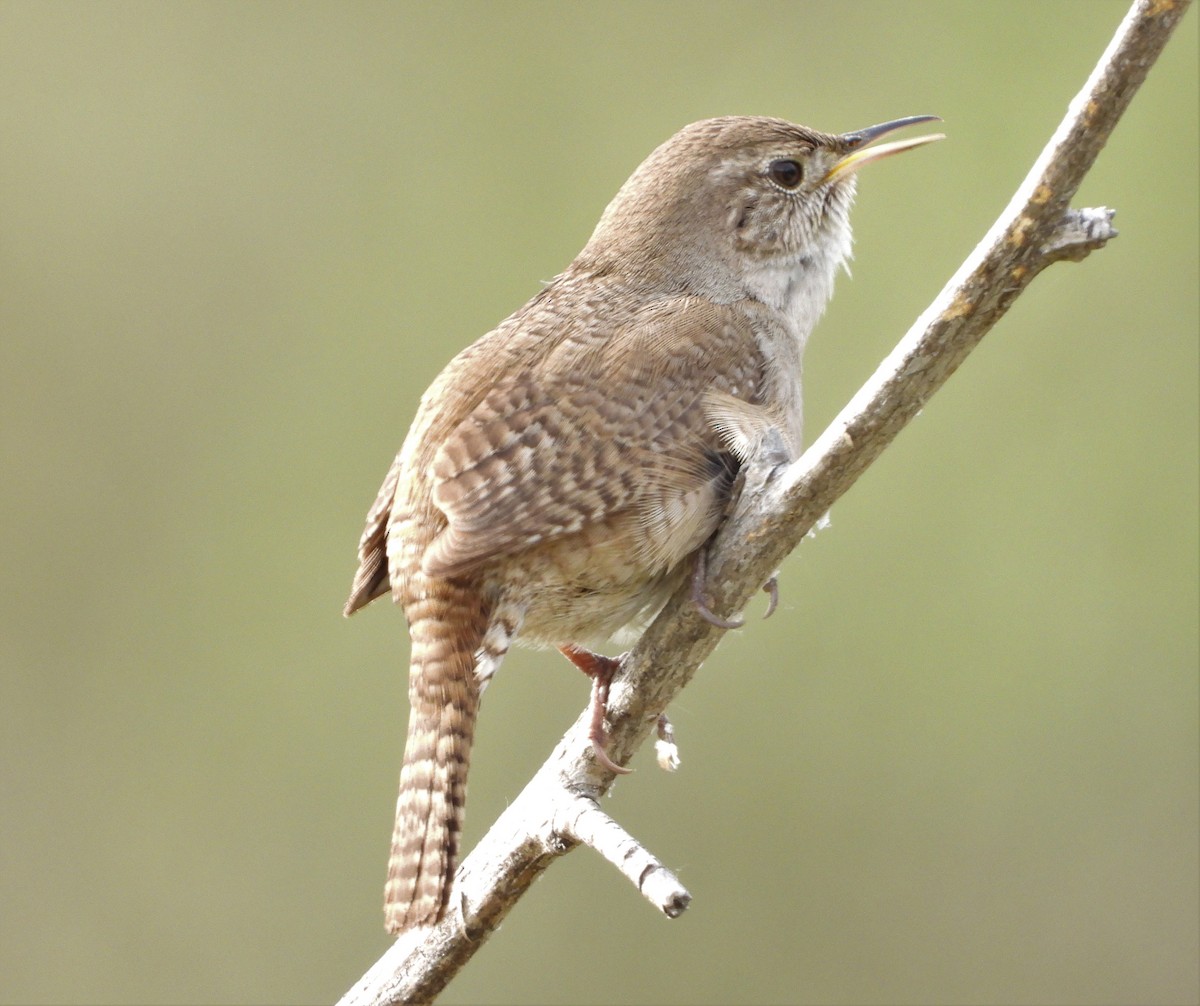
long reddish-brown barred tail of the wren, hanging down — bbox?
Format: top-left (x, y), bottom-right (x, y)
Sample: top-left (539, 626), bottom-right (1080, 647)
top-left (384, 580), bottom-right (487, 935)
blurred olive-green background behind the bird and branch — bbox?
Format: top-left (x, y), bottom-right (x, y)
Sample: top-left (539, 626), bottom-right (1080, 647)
top-left (0, 0), bottom-right (1200, 1004)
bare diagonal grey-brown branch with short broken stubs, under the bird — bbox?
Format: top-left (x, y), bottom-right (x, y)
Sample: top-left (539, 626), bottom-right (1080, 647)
top-left (342, 0), bottom-right (1189, 1006)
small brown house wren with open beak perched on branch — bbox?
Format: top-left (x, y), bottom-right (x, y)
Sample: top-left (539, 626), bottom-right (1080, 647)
top-left (346, 115), bottom-right (940, 933)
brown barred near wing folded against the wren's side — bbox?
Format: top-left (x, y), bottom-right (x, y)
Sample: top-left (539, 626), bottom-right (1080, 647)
top-left (422, 299), bottom-right (762, 576)
